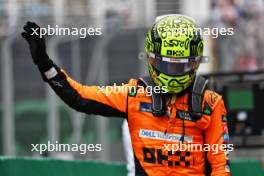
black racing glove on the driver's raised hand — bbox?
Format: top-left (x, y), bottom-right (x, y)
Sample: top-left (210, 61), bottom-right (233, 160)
top-left (21, 21), bottom-right (54, 74)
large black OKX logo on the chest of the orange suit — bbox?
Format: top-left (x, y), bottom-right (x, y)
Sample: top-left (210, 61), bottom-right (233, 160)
top-left (143, 147), bottom-right (194, 167)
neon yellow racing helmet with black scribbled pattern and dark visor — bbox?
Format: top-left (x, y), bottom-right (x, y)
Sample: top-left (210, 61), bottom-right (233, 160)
top-left (145, 14), bottom-right (205, 93)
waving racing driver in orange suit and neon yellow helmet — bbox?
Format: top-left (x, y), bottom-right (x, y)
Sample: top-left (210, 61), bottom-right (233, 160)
top-left (22, 14), bottom-right (230, 176)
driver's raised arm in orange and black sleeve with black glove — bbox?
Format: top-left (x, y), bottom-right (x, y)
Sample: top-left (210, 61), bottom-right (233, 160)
top-left (22, 22), bottom-right (127, 117)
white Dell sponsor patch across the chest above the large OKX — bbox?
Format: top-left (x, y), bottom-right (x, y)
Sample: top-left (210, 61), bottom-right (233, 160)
top-left (139, 129), bottom-right (192, 143)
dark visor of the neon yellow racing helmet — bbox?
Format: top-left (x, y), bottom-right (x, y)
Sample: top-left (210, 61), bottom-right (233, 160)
top-left (148, 53), bottom-right (208, 75)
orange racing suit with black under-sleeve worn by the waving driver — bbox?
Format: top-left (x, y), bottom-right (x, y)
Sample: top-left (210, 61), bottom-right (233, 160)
top-left (42, 65), bottom-right (230, 176)
